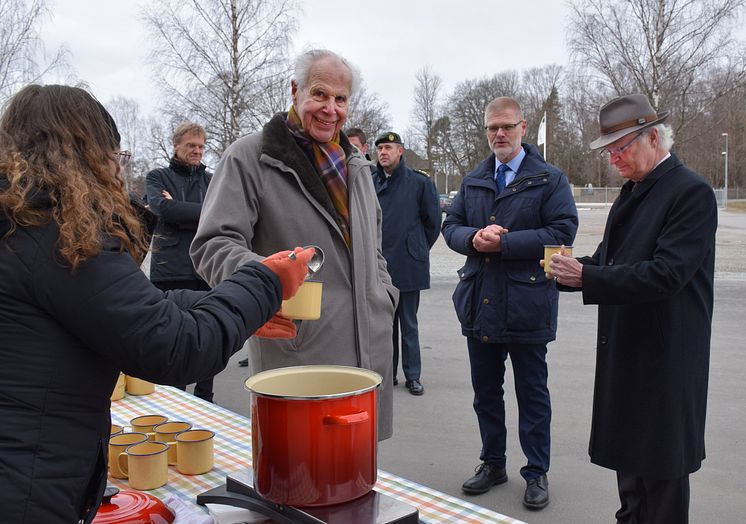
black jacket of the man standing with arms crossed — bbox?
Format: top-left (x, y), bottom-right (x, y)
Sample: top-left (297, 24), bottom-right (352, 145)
top-left (145, 158), bottom-right (212, 282)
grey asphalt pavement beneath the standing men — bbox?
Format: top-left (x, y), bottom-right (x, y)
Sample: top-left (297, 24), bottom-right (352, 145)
top-left (205, 209), bottom-right (746, 524)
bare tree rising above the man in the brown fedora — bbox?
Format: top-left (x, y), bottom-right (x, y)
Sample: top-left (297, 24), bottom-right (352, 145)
top-left (568, 0), bottom-right (746, 131)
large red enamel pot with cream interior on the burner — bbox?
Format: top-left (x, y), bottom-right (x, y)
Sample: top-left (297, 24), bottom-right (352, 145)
top-left (245, 366), bottom-right (382, 506)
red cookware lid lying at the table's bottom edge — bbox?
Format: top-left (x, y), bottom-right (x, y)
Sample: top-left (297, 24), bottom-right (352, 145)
top-left (93, 486), bottom-right (175, 524)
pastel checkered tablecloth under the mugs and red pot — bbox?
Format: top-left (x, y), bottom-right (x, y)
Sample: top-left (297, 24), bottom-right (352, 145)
top-left (109, 386), bottom-right (523, 524)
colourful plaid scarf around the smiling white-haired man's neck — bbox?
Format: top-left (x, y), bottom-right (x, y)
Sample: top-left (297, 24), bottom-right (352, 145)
top-left (286, 106), bottom-right (352, 248)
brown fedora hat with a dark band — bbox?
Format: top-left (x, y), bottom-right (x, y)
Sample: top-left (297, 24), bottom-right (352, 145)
top-left (590, 94), bottom-right (668, 149)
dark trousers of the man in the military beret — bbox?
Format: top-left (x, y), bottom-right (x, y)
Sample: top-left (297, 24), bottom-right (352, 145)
top-left (394, 291), bottom-right (422, 380)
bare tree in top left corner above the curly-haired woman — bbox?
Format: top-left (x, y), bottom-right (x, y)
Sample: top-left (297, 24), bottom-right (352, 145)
top-left (0, 0), bottom-right (67, 104)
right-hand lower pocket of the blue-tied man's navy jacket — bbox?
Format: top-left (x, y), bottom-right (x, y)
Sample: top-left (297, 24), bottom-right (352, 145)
top-left (505, 265), bottom-right (554, 332)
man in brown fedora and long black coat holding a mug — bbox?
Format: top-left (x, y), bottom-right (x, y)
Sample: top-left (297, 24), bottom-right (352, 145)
top-left (552, 95), bottom-right (717, 524)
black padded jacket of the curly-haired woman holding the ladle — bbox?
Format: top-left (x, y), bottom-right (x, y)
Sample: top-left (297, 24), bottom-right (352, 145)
top-left (0, 179), bottom-right (281, 524)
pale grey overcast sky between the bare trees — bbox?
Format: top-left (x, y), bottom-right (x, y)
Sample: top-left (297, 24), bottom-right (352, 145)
top-left (42, 0), bottom-right (568, 135)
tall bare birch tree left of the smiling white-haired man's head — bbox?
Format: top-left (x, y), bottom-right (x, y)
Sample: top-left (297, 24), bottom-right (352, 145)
top-left (143, 0), bottom-right (296, 156)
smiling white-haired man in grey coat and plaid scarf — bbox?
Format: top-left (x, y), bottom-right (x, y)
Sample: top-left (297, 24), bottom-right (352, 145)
top-left (191, 50), bottom-right (398, 439)
